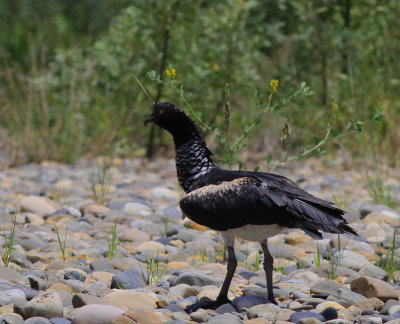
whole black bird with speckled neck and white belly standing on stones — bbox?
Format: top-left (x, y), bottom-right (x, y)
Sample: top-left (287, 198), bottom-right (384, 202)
top-left (145, 102), bottom-right (357, 312)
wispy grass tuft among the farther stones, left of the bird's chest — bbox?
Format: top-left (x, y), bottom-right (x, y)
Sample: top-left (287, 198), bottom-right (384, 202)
top-left (89, 157), bottom-right (112, 204)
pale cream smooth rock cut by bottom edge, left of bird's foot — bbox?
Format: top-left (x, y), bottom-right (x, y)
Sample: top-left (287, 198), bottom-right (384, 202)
top-left (69, 305), bottom-right (124, 324)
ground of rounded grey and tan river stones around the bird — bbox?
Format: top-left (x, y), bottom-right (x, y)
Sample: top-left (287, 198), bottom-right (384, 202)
top-left (0, 159), bottom-right (400, 324)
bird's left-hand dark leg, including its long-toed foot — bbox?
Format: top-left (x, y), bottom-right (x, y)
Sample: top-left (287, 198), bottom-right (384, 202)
top-left (186, 246), bottom-right (237, 313)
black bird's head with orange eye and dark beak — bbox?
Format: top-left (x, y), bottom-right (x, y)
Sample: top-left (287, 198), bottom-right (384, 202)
top-left (144, 102), bottom-right (197, 137)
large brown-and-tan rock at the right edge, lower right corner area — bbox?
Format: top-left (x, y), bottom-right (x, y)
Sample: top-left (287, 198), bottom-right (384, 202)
top-left (350, 276), bottom-right (399, 302)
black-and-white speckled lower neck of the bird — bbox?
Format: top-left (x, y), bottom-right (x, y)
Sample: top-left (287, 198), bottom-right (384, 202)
top-left (174, 132), bottom-right (216, 192)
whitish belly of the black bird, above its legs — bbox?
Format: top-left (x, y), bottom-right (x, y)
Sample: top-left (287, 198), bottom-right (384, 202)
top-left (221, 224), bottom-right (285, 246)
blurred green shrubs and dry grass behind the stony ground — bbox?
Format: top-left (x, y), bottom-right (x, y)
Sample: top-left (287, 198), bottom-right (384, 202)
top-left (0, 0), bottom-right (400, 166)
